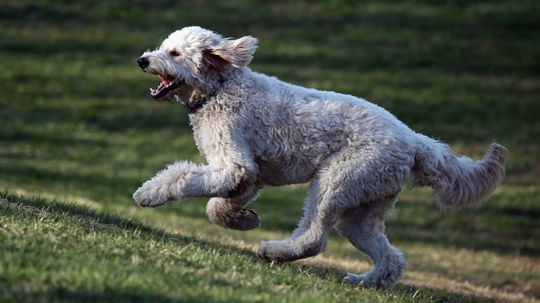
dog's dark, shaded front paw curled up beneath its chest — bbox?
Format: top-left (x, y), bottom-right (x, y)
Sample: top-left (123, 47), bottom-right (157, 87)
top-left (206, 185), bottom-right (261, 230)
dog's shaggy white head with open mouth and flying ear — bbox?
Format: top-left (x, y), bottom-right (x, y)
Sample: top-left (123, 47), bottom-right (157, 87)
top-left (137, 26), bottom-right (257, 100)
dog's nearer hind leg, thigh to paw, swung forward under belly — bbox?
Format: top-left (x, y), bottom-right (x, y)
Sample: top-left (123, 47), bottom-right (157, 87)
top-left (259, 144), bottom-right (412, 261)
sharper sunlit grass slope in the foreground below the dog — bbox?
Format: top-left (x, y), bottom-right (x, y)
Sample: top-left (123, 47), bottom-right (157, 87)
top-left (0, 196), bottom-right (490, 302)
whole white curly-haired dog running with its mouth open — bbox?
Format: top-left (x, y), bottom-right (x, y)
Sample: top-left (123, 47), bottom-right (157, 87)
top-left (133, 26), bottom-right (508, 288)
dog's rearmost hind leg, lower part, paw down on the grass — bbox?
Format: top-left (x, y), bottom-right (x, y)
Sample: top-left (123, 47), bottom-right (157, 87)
top-left (335, 199), bottom-right (405, 288)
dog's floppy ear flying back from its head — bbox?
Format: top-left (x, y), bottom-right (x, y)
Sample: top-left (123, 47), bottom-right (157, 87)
top-left (207, 36), bottom-right (257, 67)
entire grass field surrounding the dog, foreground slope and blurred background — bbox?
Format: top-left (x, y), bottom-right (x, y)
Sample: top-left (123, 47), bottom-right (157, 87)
top-left (0, 0), bottom-right (540, 302)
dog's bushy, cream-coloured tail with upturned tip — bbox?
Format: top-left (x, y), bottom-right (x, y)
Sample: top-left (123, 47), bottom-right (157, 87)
top-left (412, 134), bottom-right (509, 209)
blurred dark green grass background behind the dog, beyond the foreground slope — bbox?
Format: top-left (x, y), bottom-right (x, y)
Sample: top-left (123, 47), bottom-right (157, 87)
top-left (0, 0), bottom-right (540, 301)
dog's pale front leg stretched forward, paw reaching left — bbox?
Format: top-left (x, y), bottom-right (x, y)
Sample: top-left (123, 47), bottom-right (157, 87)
top-left (133, 162), bottom-right (254, 207)
